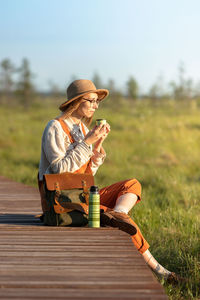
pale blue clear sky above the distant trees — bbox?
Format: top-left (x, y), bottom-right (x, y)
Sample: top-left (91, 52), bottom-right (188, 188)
top-left (0, 0), bottom-right (200, 92)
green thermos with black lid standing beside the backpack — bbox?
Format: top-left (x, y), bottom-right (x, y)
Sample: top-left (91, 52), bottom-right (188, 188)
top-left (88, 185), bottom-right (100, 228)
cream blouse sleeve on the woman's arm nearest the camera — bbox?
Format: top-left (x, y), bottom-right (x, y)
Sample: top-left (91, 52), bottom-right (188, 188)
top-left (42, 120), bottom-right (93, 173)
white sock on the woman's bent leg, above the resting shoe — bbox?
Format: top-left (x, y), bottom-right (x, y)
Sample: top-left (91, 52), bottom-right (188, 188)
top-left (113, 193), bottom-right (138, 214)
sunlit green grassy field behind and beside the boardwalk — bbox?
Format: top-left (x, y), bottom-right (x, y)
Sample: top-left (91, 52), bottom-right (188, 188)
top-left (0, 99), bottom-right (200, 300)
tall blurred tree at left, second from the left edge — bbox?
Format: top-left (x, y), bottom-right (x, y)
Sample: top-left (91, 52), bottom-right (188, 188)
top-left (16, 58), bottom-right (35, 108)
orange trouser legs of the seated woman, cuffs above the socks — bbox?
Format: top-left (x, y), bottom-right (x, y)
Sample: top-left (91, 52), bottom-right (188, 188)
top-left (100, 179), bottom-right (149, 253)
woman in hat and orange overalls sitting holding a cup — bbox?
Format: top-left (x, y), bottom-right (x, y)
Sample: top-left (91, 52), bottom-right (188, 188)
top-left (39, 79), bottom-right (181, 282)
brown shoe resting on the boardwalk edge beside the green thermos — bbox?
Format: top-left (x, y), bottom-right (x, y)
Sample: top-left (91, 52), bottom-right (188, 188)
top-left (100, 210), bottom-right (137, 235)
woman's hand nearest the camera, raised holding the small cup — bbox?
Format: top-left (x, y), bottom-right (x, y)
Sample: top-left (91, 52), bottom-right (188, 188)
top-left (84, 125), bottom-right (108, 145)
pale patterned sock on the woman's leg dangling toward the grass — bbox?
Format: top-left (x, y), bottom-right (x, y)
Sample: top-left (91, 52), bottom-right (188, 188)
top-left (142, 250), bottom-right (171, 279)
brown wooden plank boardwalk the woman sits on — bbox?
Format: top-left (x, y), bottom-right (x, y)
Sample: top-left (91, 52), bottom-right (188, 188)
top-left (0, 177), bottom-right (168, 300)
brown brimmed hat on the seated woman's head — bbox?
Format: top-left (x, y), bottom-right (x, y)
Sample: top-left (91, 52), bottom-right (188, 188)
top-left (59, 79), bottom-right (109, 111)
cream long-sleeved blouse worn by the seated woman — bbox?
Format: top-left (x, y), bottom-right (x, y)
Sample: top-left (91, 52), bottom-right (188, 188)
top-left (39, 118), bottom-right (106, 180)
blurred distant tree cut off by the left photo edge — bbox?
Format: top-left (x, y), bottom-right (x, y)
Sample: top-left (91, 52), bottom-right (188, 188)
top-left (0, 58), bottom-right (15, 96)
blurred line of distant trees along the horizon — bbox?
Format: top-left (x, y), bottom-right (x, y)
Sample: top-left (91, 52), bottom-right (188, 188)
top-left (0, 58), bottom-right (200, 107)
